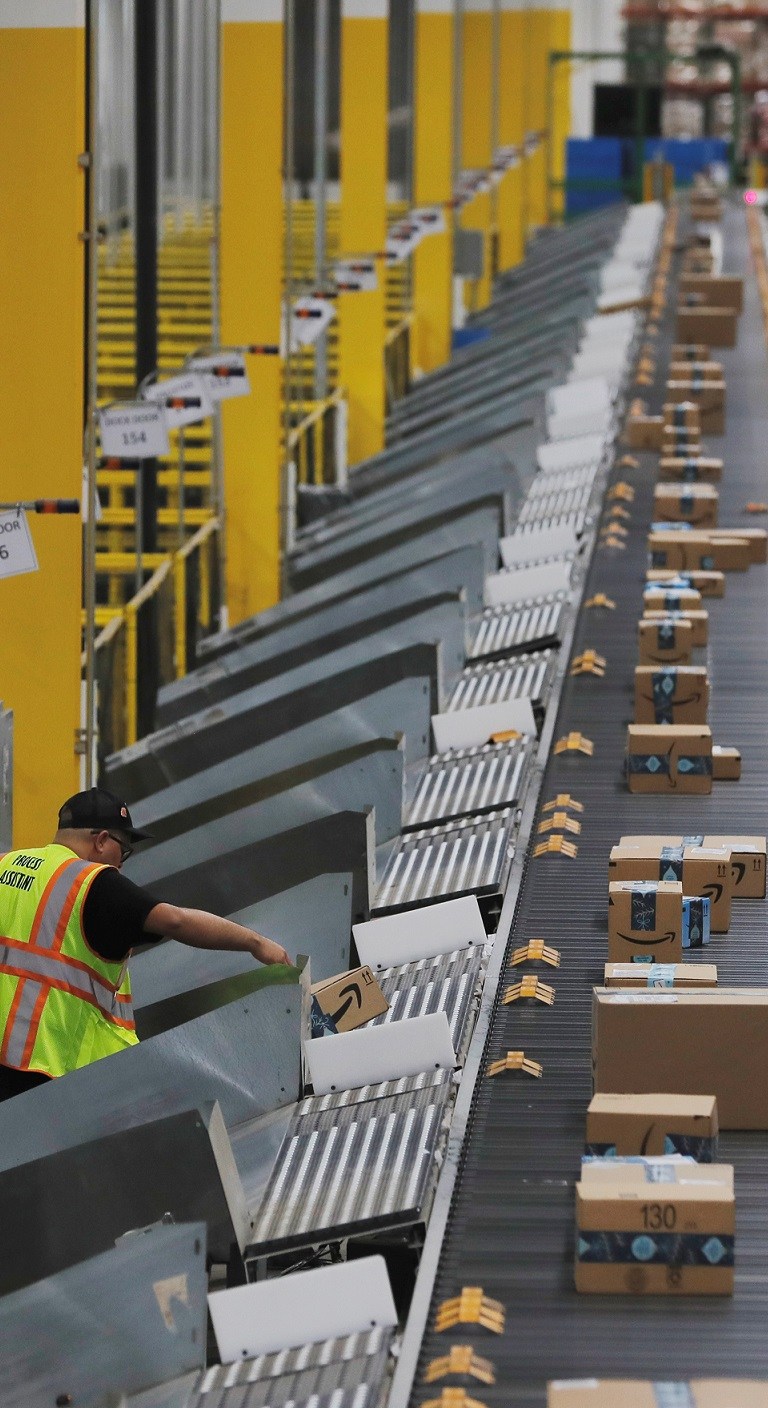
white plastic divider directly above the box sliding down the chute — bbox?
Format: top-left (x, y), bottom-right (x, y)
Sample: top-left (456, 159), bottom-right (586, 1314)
top-left (352, 894), bottom-right (488, 973)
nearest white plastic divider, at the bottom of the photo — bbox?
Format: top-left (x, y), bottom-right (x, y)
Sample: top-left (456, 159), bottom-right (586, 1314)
top-left (209, 1255), bottom-right (397, 1364)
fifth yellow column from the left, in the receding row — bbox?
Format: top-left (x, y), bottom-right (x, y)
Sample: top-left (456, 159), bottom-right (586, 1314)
top-left (461, 0), bottom-right (493, 308)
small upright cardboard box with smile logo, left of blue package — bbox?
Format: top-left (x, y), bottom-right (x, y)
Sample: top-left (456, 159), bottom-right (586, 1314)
top-left (607, 876), bottom-right (682, 963)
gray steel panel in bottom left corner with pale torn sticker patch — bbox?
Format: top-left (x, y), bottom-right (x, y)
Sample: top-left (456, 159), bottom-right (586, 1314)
top-left (0, 1222), bottom-right (207, 1408)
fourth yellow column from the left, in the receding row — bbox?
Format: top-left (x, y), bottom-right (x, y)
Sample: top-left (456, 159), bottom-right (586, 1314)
top-left (411, 0), bottom-right (454, 372)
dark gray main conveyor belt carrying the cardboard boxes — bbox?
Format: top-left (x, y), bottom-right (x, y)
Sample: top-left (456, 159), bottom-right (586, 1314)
top-left (411, 207), bottom-right (768, 1408)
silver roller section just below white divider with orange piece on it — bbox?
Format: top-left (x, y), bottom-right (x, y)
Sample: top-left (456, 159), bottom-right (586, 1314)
top-left (403, 739), bottom-right (530, 831)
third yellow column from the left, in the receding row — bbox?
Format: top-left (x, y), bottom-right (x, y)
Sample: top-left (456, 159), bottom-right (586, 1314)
top-left (338, 0), bottom-right (389, 465)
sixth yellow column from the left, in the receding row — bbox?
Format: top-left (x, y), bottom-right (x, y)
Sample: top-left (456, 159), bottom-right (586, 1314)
top-left (497, 0), bottom-right (527, 269)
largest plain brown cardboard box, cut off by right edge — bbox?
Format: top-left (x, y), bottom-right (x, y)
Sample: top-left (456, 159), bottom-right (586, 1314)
top-left (592, 987), bottom-right (768, 1129)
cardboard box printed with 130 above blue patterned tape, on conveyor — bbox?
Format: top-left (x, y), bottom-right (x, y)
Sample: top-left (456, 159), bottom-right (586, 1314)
top-left (575, 1160), bottom-right (736, 1289)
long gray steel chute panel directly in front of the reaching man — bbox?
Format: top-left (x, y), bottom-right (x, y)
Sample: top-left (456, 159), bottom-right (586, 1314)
top-left (0, 970), bottom-right (304, 1177)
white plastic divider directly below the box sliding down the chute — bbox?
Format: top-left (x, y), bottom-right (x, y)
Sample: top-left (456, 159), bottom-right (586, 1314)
top-left (303, 1011), bottom-right (457, 1095)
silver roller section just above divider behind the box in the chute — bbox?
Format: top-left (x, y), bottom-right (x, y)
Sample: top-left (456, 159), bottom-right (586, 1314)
top-left (372, 808), bottom-right (514, 914)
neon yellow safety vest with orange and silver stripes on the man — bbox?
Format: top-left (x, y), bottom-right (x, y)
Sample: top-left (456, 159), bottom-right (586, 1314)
top-left (0, 845), bottom-right (138, 1076)
